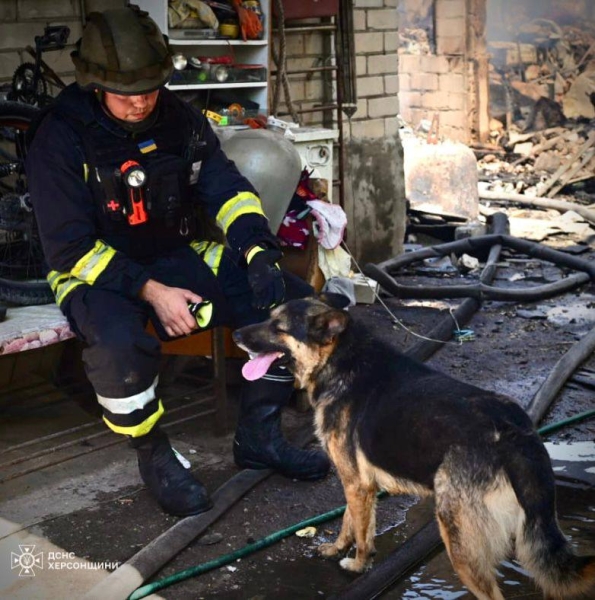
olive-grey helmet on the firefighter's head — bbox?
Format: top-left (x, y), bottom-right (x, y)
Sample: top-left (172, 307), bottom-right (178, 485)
top-left (71, 6), bottom-right (173, 95)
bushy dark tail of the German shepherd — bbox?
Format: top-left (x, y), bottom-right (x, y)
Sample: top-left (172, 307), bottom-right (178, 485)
top-left (506, 440), bottom-right (595, 600)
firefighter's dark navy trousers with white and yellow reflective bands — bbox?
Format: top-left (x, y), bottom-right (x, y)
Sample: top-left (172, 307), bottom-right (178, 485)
top-left (62, 245), bottom-right (312, 437)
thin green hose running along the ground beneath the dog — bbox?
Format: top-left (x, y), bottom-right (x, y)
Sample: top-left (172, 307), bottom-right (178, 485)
top-left (128, 410), bottom-right (595, 600)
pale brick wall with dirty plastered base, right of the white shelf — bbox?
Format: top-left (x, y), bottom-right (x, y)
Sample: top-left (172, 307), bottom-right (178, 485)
top-left (273, 0), bottom-right (405, 261)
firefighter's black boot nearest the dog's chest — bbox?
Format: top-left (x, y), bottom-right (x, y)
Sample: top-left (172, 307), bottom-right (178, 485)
top-left (233, 368), bottom-right (330, 480)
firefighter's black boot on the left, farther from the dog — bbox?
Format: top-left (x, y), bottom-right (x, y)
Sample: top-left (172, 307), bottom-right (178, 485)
top-left (130, 426), bottom-right (213, 517)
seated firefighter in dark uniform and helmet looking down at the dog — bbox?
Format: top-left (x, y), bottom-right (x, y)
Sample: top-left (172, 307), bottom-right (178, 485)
top-left (27, 7), bottom-right (329, 516)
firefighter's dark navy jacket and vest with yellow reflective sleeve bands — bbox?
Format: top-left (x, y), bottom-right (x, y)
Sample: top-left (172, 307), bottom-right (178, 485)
top-left (27, 84), bottom-right (277, 304)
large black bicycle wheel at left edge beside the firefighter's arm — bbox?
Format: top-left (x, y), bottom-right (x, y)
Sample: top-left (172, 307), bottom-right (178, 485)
top-left (0, 102), bottom-right (54, 306)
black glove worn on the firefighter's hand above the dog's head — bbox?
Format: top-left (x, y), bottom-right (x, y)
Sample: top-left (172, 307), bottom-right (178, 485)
top-left (248, 248), bottom-right (285, 309)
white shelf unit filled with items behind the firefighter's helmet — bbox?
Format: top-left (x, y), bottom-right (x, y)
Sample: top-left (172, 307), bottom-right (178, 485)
top-left (135, 0), bottom-right (270, 115)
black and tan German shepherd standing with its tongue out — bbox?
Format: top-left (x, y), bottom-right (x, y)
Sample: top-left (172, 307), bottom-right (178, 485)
top-left (234, 294), bottom-right (595, 600)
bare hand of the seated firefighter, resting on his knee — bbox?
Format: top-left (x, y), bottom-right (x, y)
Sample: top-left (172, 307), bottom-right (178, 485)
top-left (140, 279), bottom-right (202, 337)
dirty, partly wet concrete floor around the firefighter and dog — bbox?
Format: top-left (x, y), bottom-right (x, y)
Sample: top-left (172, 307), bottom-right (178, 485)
top-left (0, 223), bottom-right (595, 600)
